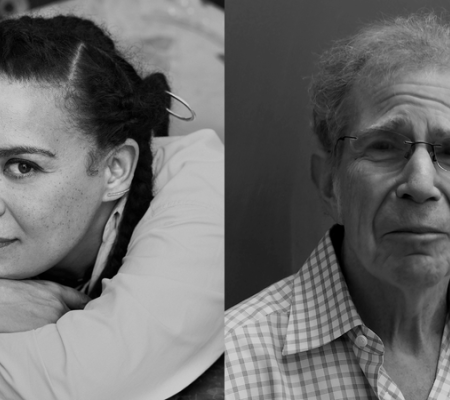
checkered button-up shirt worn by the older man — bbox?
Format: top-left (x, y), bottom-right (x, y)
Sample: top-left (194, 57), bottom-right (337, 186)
top-left (225, 228), bottom-right (450, 400)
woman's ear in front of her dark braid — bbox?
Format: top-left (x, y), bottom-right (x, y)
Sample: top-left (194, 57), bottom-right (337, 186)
top-left (103, 139), bottom-right (139, 201)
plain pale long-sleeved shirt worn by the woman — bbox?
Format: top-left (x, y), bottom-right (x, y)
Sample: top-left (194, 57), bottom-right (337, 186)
top-left (0, 130), bottom-right (224, 400)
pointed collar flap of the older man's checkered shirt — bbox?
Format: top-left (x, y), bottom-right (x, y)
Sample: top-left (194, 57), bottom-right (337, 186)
top-left (282, 225), bottom-right (363, 356)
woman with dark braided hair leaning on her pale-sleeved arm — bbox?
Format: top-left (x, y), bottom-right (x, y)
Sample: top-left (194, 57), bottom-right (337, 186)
top-left (0, 16), bottom-right (223, 400)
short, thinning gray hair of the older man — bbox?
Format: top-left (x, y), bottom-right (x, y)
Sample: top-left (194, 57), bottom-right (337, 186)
top-left (310, 14), bottom-right (450, 161)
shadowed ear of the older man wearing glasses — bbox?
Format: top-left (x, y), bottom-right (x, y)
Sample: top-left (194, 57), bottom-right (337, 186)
top-left (311, 153), bottom-right (342, 225)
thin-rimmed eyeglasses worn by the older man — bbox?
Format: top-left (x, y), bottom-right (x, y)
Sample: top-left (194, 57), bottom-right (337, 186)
top-left (335, 131), bottom-right (450, 171)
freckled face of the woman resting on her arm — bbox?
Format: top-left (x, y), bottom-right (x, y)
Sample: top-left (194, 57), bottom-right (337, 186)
top-left (0, 79), bottom-right (111, 278)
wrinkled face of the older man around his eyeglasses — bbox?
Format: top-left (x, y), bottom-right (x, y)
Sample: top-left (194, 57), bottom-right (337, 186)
top-left (334, 72), bottom-right (450, 287)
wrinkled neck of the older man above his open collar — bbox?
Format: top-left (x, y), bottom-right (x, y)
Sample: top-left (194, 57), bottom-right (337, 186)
top-left (332, 227), bottom-right (449, 353)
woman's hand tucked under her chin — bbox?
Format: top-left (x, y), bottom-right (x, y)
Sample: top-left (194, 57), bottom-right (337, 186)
top-left (0, 279), bottom-right (90, 333)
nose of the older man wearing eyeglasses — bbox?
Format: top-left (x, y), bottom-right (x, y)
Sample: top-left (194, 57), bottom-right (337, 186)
top-left (396, 143), bottom-right (442, 203)
